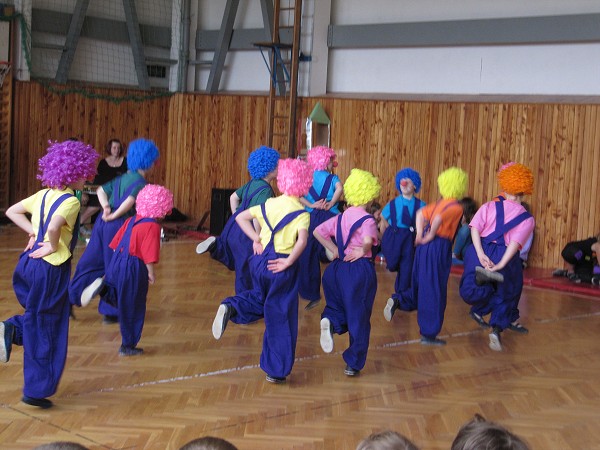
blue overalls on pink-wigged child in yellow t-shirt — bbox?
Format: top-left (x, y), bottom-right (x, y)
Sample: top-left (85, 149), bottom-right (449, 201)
top-left (223, 203), bottom-right (306, 378)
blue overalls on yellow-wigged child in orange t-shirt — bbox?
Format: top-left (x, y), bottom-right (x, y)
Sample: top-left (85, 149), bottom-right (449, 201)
top-left (399, 201), bottom-right (458, 339)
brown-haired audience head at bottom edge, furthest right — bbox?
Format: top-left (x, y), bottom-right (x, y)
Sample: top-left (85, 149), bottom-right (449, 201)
top-left (451, 414), bottom-right (529, 450)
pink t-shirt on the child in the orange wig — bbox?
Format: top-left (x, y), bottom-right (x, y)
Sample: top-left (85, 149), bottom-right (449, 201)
top-left (469, 200), bottom-right (535, 247)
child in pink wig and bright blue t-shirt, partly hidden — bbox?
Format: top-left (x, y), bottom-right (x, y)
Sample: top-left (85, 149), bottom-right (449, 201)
top-left (300, 146), bottom-right (343, 310)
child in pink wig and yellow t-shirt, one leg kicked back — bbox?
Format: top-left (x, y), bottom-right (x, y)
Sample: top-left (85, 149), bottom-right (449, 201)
top-left (212, 159), bottom-right (312, 383)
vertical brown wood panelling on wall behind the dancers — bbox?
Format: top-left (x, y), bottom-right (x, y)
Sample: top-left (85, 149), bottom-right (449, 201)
top-left (11, 82), bottom-right (600, 268)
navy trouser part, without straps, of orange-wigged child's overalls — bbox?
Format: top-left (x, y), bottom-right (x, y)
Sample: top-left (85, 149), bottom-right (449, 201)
top-left (460, 242), bottom-right (523, 330)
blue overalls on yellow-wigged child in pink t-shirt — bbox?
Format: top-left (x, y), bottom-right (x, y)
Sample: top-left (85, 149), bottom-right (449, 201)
top-left (321, 214), bottom-right (377, 370)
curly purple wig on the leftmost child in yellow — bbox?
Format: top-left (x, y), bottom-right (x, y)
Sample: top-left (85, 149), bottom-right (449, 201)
top-left (37, 140), bottom-right (100, 189)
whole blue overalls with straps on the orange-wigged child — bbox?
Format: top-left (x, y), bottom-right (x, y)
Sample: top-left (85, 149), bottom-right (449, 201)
top-left (460, 196), bottom-right (531, 330)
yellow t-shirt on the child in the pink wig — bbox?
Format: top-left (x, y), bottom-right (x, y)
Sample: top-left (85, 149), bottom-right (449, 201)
top-left (248, 195), bottom-right (310, 255)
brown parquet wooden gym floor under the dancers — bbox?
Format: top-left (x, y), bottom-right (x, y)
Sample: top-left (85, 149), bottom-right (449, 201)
top-left (0, 226), bottom-right (600, 450)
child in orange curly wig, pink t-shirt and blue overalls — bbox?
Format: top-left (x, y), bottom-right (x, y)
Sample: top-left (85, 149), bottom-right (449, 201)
top-left (460, 162), bottom-right (535, 351)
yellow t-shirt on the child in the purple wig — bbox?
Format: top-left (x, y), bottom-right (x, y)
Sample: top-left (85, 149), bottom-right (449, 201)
top-left (21, 188), bottom-right (81, 266)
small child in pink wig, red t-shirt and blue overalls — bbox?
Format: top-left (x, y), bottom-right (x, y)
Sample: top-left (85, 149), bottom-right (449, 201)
top-left (104, 184), bottom-right (173, 356)
